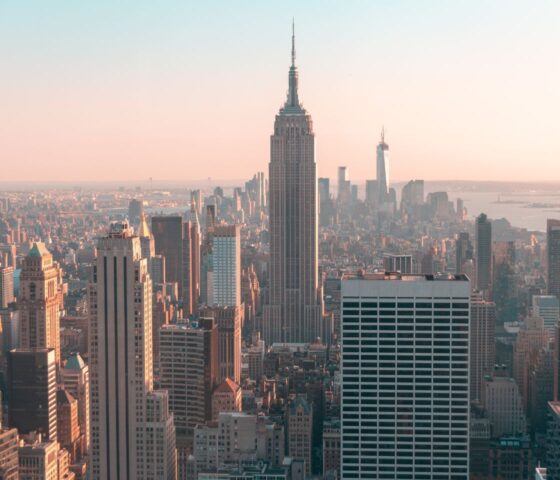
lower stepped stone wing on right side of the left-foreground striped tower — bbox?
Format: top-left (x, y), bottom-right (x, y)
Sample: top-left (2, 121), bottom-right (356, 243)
top-left (146, 390), bottom-right (177, 480)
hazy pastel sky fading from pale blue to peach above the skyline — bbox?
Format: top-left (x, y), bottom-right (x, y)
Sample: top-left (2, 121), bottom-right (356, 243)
top-left (0, 0), bottom-right (560, 183)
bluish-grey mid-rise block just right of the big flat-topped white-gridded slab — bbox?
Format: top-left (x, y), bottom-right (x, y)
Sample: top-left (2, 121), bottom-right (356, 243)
top-left (482, 367), bottom-right (527, 438)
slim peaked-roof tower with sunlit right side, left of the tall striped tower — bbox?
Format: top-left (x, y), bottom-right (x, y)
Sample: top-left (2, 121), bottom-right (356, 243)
top-left (60, 353), bottom-right (90, 455)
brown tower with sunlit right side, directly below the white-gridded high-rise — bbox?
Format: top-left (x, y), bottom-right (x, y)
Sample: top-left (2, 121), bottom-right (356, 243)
top-left (201, 306), bottom-right (243, 384)
